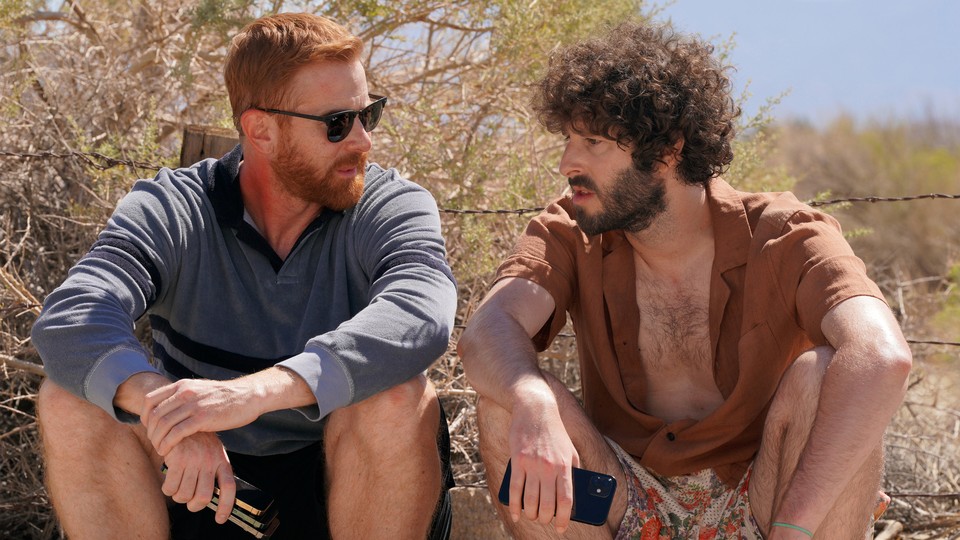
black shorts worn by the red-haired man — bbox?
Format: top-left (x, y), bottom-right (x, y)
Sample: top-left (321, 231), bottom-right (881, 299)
top-left (170, 396), bottom-right (454, 540)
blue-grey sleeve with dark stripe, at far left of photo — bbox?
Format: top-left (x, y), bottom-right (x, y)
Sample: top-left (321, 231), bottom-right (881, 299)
top-left (31, 169), bottom-right (192, 421)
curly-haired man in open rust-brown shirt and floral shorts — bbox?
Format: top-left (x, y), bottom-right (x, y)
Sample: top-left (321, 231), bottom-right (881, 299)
top-left (458, 23), bottom-right (911, 539)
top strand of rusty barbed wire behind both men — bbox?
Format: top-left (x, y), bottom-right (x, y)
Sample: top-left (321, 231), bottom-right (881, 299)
top-left (0, 150), bottom-right (960, 216)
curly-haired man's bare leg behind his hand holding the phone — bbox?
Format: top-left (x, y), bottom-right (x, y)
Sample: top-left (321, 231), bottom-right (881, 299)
top-left (477, 374), bottom-right (627, 539)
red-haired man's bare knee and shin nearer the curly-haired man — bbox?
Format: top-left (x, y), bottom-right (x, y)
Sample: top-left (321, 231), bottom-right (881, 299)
top-left (324, 375), bottom-right (441, 539)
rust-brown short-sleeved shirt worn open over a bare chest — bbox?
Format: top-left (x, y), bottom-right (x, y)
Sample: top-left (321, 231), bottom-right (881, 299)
top-left (497, 179), bottom-right (883, 485)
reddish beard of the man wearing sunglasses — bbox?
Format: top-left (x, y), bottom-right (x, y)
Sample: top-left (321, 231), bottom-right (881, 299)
top-left (271, 140), bottom-right (367, 212)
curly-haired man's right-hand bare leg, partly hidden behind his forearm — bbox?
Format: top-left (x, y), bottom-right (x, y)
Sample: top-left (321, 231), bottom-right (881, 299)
top-left (750, 347), bottom-right (883, 539)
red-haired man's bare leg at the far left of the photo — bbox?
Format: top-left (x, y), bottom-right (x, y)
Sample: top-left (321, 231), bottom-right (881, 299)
top-left (37, 379), bottom-right (170, 540)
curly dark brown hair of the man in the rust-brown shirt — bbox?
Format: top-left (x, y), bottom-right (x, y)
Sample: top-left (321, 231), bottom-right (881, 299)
top-left (534, 23), bottom-right (740, 184)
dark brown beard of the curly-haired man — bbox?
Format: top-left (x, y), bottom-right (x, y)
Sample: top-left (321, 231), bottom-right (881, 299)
top-left (570, 167), bottom-right (667, 236)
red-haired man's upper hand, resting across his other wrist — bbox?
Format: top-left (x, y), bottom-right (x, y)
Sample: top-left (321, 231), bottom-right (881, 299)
top-left (140, 379), bottom-right (264, 458)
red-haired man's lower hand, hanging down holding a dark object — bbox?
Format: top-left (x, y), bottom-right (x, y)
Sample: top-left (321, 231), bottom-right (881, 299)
top-left (161, 433), bottom-right (237, 524)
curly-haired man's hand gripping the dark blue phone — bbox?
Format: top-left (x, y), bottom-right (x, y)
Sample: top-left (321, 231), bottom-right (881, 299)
top-left (510, 394), bottom-right (580, 534)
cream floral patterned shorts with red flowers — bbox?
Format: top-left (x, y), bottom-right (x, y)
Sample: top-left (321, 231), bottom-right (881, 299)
top-left (608, 439), bottom-right (763, 540)
